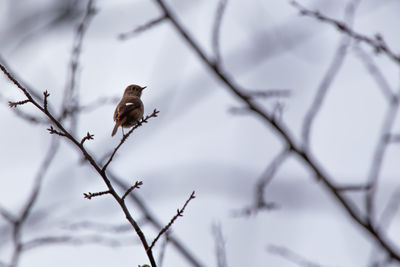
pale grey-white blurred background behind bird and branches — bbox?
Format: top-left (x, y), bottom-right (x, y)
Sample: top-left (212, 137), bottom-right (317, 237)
top-left (0, 0), bottom-right (400, 267)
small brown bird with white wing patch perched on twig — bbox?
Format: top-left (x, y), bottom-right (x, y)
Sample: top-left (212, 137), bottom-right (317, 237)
top-left (111, 84), bottom-right (146, 136)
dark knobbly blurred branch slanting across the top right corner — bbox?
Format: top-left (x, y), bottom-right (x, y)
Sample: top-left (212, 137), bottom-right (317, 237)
top-left (292, 1), bottom-right (400, 64)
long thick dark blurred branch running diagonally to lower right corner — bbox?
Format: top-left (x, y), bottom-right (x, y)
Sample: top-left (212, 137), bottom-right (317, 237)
top-left (155, 0), bottom-right (400, 262)
